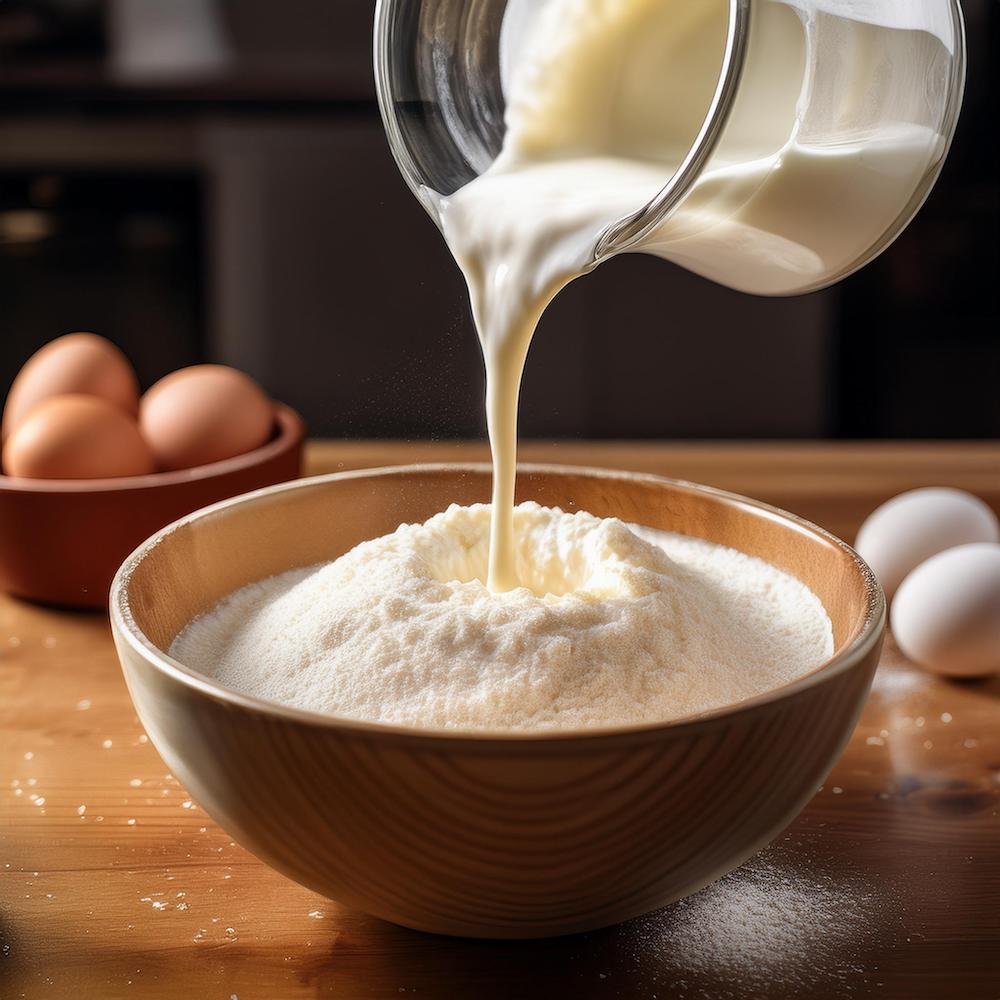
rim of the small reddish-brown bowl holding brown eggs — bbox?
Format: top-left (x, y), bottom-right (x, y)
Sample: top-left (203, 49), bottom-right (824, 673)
top-left (0, 400), bottom-right (306, 492)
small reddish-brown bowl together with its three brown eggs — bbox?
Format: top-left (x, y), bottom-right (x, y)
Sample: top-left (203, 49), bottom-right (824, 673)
top-left (0, 333), bottom-right (304, 608)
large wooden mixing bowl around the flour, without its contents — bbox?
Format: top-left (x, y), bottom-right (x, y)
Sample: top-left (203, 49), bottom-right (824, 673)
top-left (111, 466), bottom-right (885, 938)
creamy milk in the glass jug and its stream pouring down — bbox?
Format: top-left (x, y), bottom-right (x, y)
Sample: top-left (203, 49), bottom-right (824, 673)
top-left (424, 0), bottom-right (943, 591)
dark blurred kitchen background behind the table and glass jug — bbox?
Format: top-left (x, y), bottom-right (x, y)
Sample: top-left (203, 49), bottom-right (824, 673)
top-left (0, 0), bottom-right (1000, 438)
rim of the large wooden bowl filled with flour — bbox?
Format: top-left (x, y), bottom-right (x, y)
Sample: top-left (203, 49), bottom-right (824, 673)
top-left (108, 462), bottom-right (887, 746)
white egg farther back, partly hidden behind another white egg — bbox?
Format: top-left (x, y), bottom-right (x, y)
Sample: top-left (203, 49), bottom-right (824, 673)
top-left (854, 486), bottom-right (1000, 600)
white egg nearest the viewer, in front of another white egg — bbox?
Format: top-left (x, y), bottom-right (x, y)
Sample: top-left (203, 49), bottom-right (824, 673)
top-left (892, 543), bottom-right (1000, 677)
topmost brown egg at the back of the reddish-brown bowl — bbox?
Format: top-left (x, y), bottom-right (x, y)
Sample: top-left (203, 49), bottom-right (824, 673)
top-left (3, 333), bottom-right (139, 439)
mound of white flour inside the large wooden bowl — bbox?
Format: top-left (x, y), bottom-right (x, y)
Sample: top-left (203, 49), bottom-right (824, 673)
top-left (170, 503), bottom-right (833, 730)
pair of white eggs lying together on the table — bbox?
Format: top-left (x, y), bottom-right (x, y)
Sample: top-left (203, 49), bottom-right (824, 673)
top-left (855, 487), bottom-right (1000, 678)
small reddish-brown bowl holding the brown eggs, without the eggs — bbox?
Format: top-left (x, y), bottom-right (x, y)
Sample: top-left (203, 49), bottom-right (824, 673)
top-left (0, 403), bottom-right (305, 608)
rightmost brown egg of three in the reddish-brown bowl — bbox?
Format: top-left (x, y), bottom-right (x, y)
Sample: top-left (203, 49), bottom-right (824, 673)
top-left (139, 365), bottom-right (274, 469)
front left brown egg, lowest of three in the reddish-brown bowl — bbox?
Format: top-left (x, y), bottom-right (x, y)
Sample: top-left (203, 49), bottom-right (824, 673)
top-left (3, 395), bottom-right (156, 479)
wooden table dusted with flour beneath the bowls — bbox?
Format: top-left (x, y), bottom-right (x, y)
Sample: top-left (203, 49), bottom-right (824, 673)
top-left (0, 442), bottom-right (1000, 1000)
